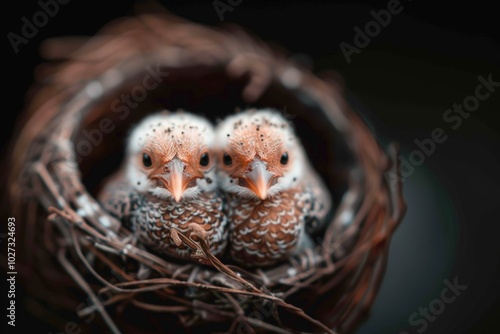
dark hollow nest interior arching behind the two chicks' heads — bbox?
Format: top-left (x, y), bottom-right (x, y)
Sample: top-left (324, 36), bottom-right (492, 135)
top-left (80, 66), bottom-right (355, 203)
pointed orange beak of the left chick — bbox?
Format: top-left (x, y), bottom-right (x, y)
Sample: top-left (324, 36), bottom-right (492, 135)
top-left (158, 158), bottom-right (196, 203)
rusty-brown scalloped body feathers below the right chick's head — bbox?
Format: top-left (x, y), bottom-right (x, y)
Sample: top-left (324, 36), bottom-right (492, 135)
top-left (227, 177), bottom-right (330, 266)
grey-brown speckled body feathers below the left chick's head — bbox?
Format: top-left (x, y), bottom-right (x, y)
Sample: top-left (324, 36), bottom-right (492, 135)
top-left (99, 176), bottom-right (228, 259)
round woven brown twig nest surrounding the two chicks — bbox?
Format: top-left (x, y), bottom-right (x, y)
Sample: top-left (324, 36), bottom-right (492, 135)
top-left (9, 14), bottom-right (405, 333)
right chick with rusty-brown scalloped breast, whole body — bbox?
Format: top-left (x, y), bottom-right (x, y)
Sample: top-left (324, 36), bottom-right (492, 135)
top-left (216, 109), bottom-right (331, 267)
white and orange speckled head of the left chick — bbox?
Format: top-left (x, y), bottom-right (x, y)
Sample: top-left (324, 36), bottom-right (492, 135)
top-left (126, 112), bottom-right (216, 202)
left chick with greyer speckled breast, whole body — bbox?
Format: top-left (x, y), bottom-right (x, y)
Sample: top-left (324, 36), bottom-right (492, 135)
top-left (99, 112), bottom-right (227, 259)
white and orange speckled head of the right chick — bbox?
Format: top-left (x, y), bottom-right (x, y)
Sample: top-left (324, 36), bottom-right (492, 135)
top-left (216, 109), bottom-right (304, 200)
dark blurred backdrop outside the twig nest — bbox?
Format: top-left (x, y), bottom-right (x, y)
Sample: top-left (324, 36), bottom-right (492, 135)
top-left (0, 0), bottom-right (500, 333)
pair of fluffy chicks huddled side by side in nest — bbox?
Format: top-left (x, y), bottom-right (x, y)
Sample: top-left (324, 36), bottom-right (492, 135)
top-left (99, 109), bottom-right (331, 267)
